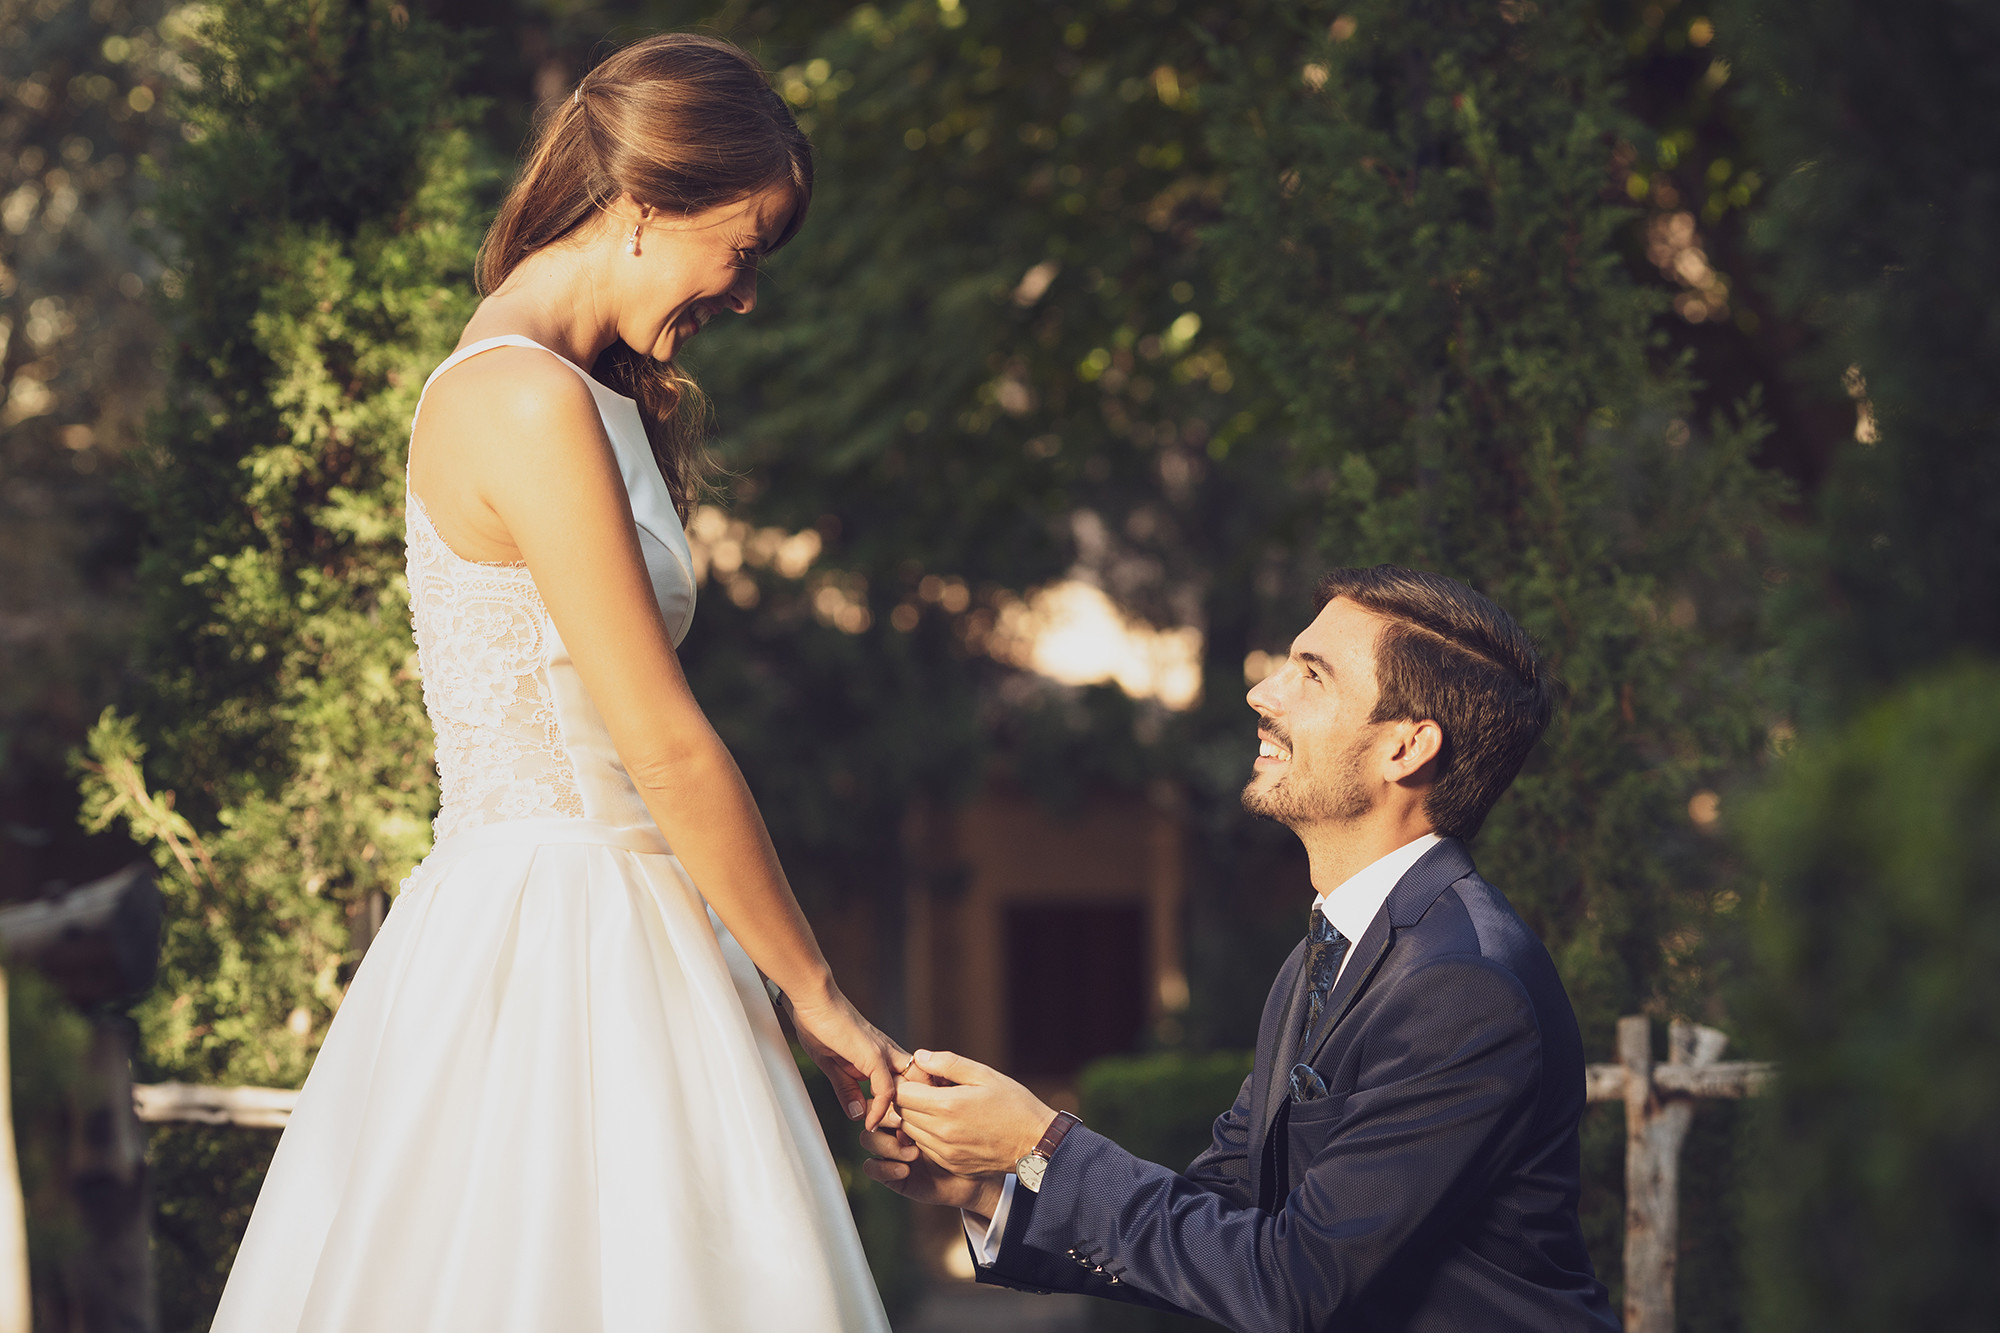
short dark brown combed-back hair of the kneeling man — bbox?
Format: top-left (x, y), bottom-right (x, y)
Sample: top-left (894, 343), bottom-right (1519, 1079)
top-left (1320, 564), bottom-right (1560, 839)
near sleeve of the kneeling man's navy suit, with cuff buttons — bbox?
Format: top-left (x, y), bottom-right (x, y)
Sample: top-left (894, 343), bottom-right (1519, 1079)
top-left (982, 957), bottom-right (1542, 1333)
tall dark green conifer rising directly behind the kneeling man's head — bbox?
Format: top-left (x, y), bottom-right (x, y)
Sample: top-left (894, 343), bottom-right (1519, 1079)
top-left (1210, 0), bottom-right (1774, 1024)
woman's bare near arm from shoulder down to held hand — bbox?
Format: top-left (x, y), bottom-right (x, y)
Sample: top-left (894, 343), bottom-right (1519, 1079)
top-left (410, 348), bottom-right (902, 1129)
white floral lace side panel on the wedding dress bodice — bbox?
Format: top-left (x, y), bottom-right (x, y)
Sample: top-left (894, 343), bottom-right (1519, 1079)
top-left (404, 494), bottom-right (584, 843)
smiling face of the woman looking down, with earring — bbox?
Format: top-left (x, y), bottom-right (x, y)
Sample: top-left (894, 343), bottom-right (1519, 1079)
top-left (610, 186), bottom-right (798, 362)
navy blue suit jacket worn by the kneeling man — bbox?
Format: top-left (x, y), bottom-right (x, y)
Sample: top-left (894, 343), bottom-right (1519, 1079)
top-left (978, 839), bottom-right (1618, 1333)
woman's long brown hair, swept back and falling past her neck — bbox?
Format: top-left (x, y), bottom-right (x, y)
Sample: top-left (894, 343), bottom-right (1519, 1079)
top-left (478, 32), bottom-right (812, 518)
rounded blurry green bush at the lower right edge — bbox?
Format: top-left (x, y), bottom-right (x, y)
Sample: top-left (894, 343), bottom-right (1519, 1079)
top-left (1742, 662), bottom-right (2000, 1333)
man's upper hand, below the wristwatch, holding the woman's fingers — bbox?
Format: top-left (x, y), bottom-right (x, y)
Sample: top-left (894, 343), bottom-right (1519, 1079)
top-left (896, 1051), bottom-right (1056, 1177)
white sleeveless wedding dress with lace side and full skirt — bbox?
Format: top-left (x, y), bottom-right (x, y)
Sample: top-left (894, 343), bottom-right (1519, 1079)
top-left (212, 336), bottom-right (888, 1333)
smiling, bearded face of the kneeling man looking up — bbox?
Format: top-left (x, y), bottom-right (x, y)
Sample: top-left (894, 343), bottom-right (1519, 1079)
top-left (1244, 596), bottom-right (1384, 829)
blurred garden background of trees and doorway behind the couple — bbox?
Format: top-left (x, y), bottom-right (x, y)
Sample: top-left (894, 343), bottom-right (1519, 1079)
top-left (0, 0), bottom-right (2000, 1331)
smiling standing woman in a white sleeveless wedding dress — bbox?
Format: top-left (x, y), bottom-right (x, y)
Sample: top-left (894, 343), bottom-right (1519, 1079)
top-left (214, 36), bottom-right (908, 1333)
